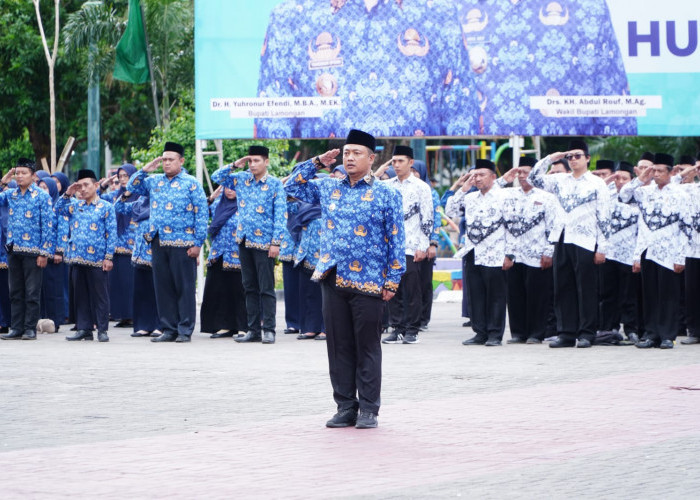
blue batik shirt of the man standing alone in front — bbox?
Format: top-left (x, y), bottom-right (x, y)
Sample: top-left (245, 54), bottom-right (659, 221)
top-left (285, 160), bottom-right (406, 296)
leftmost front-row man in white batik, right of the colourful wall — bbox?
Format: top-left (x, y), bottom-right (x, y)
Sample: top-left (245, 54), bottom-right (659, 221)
top-left (445, 160), bottom-right (514, 346)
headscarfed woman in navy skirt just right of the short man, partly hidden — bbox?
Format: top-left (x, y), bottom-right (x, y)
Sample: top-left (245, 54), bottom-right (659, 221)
top-left (100, 163), bottom-right (136, 328)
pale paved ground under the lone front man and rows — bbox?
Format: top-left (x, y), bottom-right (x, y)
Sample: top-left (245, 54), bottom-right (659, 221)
top-left (0, 304), bottom-right (700, 499)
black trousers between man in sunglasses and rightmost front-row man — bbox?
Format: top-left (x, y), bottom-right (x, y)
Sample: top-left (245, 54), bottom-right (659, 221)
top-left (598, 260), bottom-right (639, 334)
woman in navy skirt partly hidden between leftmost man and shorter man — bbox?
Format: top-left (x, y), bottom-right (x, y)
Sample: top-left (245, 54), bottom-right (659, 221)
top-left (38, 175), bottom-right (68, 332)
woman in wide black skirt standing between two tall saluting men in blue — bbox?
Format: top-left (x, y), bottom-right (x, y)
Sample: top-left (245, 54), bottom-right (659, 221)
top-left (199, 188), bottom-right (248, 339)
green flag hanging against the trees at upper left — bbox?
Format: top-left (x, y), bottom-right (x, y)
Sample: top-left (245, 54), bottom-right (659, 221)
top-left (113, 0), bottom-right (148, 83)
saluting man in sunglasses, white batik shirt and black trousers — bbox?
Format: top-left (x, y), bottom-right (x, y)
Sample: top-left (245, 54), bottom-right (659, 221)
top-left (528, 140), bottom-right (610, 347)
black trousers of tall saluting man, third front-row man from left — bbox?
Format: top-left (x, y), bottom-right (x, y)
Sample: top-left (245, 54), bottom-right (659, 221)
top-left (151, 236), bottom-right (197, 337)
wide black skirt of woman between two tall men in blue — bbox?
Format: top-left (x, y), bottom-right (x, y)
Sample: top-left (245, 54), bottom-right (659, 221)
top-left (199, 257), bottom-right (248, 333)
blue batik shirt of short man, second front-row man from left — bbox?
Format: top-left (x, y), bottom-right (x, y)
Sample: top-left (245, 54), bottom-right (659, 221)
top-left (56, 195), bottom-right (117, 267)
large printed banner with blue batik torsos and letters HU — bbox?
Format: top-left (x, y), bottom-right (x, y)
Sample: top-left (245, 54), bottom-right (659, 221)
top-left (195, 0), bottom-right (700, 139)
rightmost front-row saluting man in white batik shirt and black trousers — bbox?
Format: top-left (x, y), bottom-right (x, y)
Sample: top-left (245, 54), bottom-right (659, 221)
top-left (620, 153), bottom-right (691, 349)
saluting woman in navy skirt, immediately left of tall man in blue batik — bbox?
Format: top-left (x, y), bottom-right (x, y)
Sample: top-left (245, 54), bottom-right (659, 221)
top-left (112, 191), bottom-right (161, 337)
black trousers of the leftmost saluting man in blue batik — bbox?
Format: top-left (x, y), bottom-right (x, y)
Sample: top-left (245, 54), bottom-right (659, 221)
top-left (7, 253), bottom-right (43, 332)
